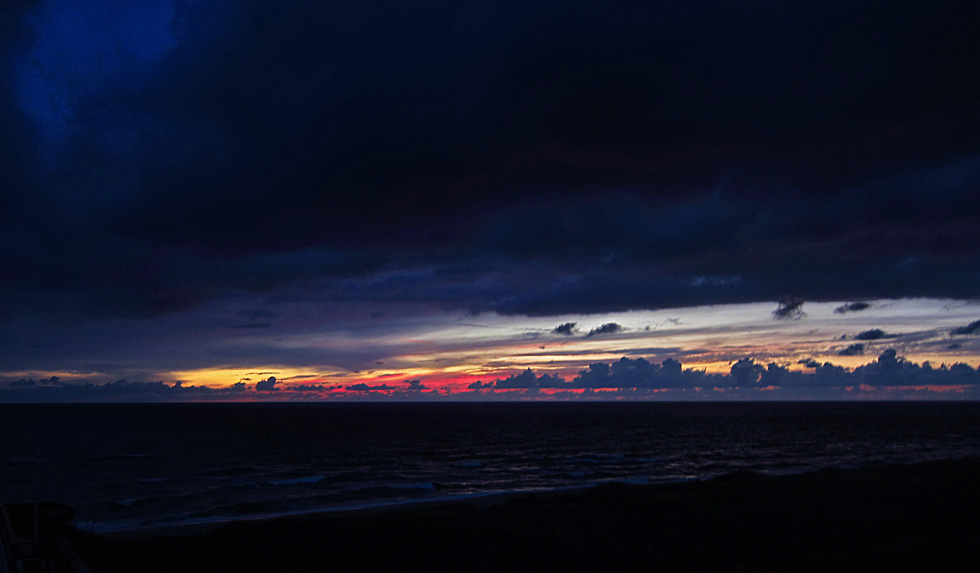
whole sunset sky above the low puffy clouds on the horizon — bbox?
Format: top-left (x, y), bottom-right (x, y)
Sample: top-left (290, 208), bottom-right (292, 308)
top-left (0, 0), bottom-right (980, 400)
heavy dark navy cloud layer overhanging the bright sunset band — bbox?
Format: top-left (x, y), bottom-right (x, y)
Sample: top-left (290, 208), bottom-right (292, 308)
top-left (0, 0), bottom-right (980, 322)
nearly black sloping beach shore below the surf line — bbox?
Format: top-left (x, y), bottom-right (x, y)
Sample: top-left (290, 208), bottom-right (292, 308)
top-left (63, 458), bottom-right (980, 573)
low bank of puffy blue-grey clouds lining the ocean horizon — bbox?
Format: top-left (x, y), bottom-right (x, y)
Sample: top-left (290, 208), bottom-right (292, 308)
top-left (0, 344), bottom-right (980, 403)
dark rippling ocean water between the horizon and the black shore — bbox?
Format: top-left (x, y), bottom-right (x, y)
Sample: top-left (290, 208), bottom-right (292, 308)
top-left (0, 402), bottom-right (980, 531)
